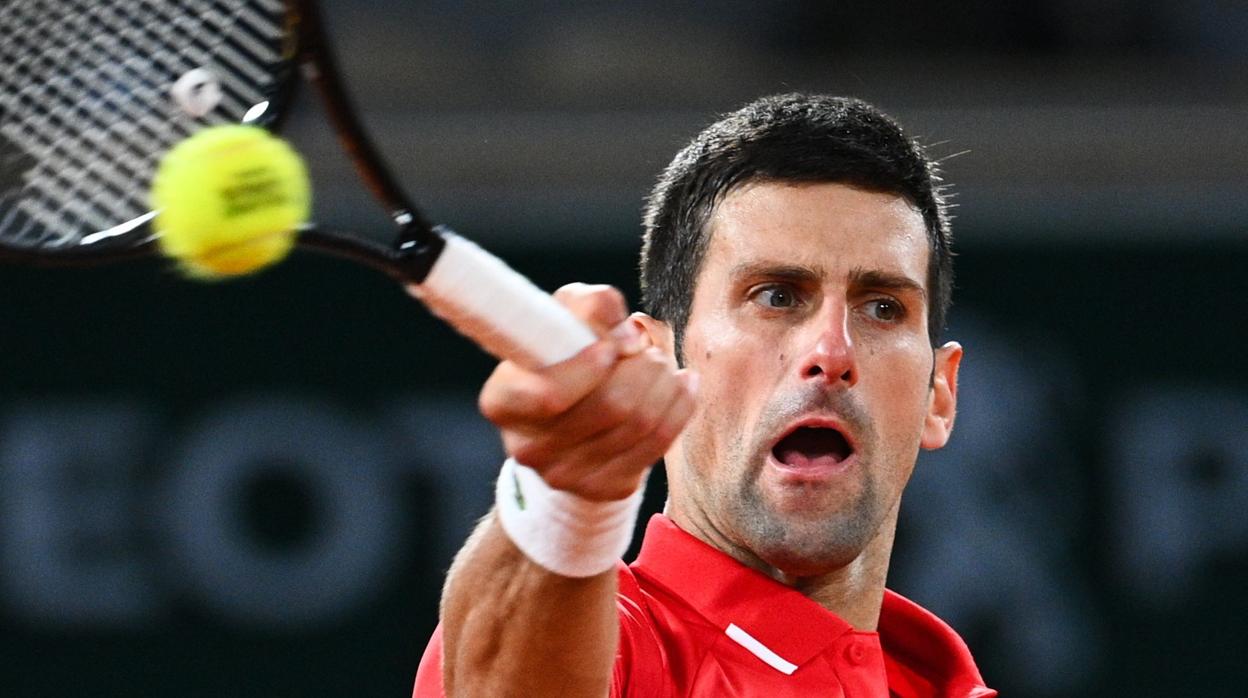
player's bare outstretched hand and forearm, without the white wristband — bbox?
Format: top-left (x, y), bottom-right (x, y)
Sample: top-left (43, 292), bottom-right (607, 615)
top-left (442, 285), bottom-right (694, 698)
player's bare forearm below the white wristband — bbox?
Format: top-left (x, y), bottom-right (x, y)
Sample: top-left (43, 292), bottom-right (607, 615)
top-left (442, 513), bottom-right (619, 698)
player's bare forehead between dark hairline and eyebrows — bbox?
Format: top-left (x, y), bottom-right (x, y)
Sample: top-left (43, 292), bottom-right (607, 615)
top-left (699, 182), bottom-right (930, 288)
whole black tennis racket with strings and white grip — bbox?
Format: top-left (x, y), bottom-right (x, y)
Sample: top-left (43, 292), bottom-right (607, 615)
top-left (0, 0), bottom-right (595, 367)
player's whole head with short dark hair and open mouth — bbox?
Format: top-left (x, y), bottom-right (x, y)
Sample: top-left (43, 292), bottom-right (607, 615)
top-left (641, 95), bottom-right (961, 577)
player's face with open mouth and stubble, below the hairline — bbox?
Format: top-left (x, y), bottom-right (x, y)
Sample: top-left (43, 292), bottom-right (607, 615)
top-left (666, 182), bottom-right (961, 577)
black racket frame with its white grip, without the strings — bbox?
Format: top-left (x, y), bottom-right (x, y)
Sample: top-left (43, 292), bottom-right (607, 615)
top-left (0, 0), bottom-right (597, 367)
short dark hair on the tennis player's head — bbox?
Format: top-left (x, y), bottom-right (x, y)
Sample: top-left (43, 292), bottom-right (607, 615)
top-left (641, 94), bottom-right (953, 362)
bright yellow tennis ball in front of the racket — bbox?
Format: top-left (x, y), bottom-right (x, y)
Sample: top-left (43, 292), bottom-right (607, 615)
top-left (151, 125), bottom-right (311, 278)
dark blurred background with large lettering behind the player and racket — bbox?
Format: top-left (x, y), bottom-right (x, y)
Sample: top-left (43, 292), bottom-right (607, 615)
top-left (0, 0), bottom-right (1248, 698)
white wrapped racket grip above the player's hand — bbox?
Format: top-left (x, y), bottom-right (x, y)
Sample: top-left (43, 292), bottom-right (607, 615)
top-left (408, 232), bottom-right (598, 368)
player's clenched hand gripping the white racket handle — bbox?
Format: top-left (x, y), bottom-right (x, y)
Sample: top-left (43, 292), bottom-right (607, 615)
top-left (479, 283), bottom-right (695, 501)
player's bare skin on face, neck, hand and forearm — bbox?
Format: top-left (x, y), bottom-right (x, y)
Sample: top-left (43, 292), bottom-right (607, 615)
top-left (429, 182), bottom-right (962, 697)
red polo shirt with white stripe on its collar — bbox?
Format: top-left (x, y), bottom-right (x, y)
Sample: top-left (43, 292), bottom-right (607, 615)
top-left (413, 516), bottom-right (996, 698)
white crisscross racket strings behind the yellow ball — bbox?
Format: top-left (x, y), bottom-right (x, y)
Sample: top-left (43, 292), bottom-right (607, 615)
top-left (0, 0), bottom-right (286, 248)
